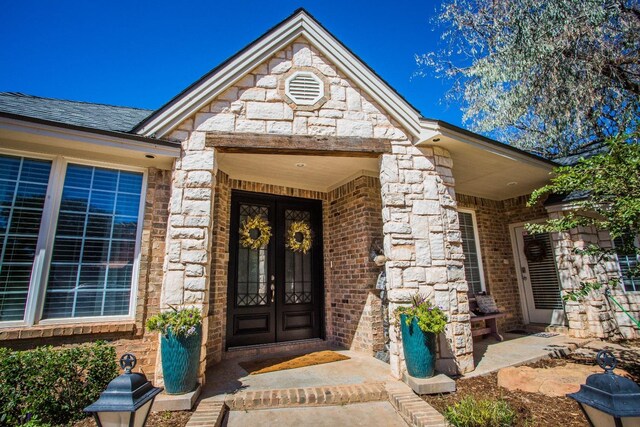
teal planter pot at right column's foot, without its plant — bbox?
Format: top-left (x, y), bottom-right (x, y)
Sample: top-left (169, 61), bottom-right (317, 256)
top-left (400, 314), bottom-right (436, 378)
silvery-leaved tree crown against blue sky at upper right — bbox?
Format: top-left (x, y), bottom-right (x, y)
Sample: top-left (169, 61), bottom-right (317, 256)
top-left (416, 0), bottom-right (640, 157)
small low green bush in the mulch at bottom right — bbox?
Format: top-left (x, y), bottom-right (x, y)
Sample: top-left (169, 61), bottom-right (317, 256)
top-left (444, 397), bottom-right (516, 427)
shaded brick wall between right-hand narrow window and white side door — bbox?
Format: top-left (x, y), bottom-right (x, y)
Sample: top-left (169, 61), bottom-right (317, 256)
top-left (458, 194), bottom-right (547, 331)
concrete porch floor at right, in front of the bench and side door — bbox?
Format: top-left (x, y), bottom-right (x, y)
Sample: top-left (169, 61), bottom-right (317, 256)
top-left (464, 333), bottom-right (589, 378)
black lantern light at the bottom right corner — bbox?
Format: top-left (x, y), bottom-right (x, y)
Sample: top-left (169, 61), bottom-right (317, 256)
top-left (567, 350), bottom-right (640, 427)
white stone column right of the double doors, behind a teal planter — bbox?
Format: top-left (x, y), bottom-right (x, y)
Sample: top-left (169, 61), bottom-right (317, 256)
top-left (380, 141), bottom-right (474, 378)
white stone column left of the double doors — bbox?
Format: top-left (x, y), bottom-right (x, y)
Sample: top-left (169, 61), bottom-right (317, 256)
top-left (156, 132), bottom-right (217, 381)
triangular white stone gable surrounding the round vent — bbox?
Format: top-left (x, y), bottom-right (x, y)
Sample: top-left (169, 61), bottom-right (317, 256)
top-left (170, 37), bottom-right (407, 141)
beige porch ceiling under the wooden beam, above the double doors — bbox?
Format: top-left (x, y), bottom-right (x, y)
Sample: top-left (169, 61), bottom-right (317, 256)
top-left (218, 152), bottom-right (378, 192)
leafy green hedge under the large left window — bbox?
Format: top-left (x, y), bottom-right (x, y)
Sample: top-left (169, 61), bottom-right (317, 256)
top-left (0, 342), bottom-right (118, 425)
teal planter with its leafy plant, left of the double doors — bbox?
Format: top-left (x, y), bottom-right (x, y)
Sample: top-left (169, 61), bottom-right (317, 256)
top-left (147, 307), bottom-right (202, 394)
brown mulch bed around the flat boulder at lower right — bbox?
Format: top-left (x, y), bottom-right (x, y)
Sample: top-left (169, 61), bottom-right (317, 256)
top-left (422, 341), bottom-right (640, 427)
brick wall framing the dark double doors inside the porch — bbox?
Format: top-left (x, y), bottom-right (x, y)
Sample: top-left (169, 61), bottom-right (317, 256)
top-left (207, 171), bottom-right (384, 364)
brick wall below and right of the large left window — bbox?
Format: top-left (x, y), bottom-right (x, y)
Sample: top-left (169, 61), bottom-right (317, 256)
top-left (0, 169), bottom-right (171, 380)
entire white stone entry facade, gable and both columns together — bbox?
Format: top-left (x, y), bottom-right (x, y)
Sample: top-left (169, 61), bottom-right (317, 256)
top-left (162, 38), bottom-right (473, 375)
